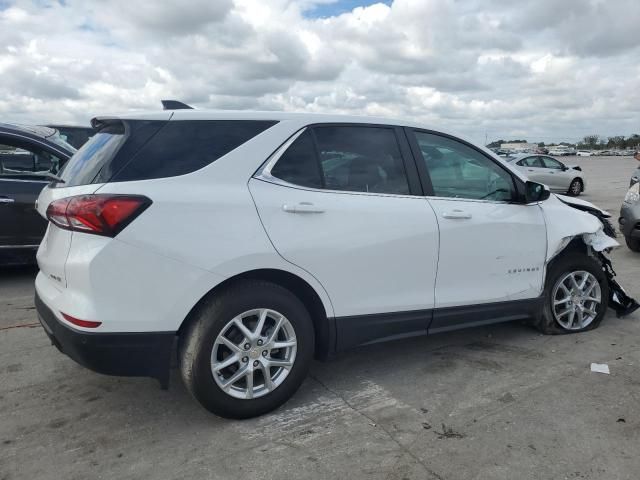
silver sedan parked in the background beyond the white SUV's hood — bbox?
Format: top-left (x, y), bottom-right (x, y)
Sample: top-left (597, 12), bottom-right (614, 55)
top-left (506, 153), bottom-right (585, 196)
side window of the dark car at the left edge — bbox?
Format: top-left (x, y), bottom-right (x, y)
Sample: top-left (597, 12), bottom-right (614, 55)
top-left (0, 143), bottom-right (64, 181)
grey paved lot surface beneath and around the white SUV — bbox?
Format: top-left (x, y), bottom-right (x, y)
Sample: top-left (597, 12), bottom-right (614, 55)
top-left (0, 157), bottom-right (640, 480)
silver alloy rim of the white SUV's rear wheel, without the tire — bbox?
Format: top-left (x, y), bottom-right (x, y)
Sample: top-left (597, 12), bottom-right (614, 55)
top-left (211, 308), bottom-right (298, 399)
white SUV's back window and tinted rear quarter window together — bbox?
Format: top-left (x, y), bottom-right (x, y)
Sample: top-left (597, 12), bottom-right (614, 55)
top-left (60, 120), bottom-right (277, 186)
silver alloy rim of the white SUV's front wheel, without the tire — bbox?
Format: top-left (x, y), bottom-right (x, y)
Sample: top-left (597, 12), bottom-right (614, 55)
top-left (551, 270), bottom-right (602, 330)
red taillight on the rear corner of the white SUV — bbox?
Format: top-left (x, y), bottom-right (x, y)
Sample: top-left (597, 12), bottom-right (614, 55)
top-left (47, 194), bottom-right (151, 237)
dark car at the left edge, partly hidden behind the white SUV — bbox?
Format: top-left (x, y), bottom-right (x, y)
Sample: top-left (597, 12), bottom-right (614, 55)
top-left (0, 124), bottom-right (76, 265)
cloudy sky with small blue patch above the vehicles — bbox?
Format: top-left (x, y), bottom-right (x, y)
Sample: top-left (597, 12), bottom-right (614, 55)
top-left (0, 0), bottom-right (640, 143)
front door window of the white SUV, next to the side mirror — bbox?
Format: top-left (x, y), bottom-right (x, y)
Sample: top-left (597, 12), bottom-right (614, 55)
top-left (415, 132), bottom-right (515, 201)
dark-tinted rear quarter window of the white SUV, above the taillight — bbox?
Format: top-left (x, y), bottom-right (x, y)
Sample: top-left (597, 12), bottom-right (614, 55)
top-left (112, 120), bottom-right (276, 182)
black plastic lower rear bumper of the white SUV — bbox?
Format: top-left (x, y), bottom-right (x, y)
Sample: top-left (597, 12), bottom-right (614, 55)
top-left (35, 293), bottom-right (176, 388)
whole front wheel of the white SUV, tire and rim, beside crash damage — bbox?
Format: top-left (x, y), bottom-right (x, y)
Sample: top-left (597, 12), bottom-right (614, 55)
top-left (538, 252), bottom-right (609, 335)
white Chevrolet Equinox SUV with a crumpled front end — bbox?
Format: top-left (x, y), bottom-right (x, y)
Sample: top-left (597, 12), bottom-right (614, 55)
top-left (36, 110), bottom-right (617, 418)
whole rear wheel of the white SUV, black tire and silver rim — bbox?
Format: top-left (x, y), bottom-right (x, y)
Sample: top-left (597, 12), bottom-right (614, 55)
top-left (179, 281), bottom-right (314, 418)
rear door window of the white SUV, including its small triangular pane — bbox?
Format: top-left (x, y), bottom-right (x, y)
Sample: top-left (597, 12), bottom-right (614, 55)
top-left (271, 126), bottom-right (409, 195)
